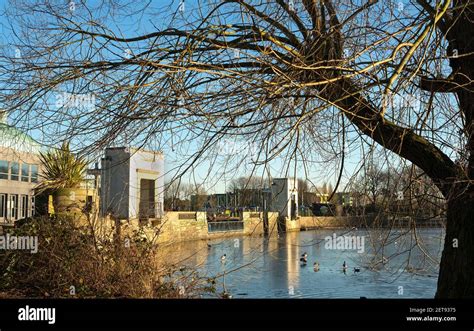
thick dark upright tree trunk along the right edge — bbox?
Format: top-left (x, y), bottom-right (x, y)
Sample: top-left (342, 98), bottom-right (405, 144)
top-left (436, 0), bottom-right (474, 299)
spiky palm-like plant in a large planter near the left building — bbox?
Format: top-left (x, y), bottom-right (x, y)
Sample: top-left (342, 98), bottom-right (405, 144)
top-left (37, 141), bottom-right (87, 193)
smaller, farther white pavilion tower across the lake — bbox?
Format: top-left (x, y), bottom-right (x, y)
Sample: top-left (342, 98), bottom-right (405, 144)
top-left (271, 178), bottom-right (298, 220)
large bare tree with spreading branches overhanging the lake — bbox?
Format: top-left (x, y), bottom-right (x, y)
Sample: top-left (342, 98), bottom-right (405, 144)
top-left (0, 0), bottom-right (474, 298)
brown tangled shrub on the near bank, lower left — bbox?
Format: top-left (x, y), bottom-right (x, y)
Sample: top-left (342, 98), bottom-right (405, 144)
top-left (0, 218), bottom-right (213, 298)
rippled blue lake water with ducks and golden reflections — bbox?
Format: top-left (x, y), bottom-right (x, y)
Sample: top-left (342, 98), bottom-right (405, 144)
top-left (163, 228), bottom-right (444, 298)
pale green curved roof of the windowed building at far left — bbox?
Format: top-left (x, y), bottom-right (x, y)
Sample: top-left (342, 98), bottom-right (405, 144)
top-left (0, 123), bottom-right (41, 154)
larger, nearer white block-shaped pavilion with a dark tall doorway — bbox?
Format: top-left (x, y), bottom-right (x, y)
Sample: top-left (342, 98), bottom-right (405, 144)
top-left (101, 147), bottom-right (164, 219)
